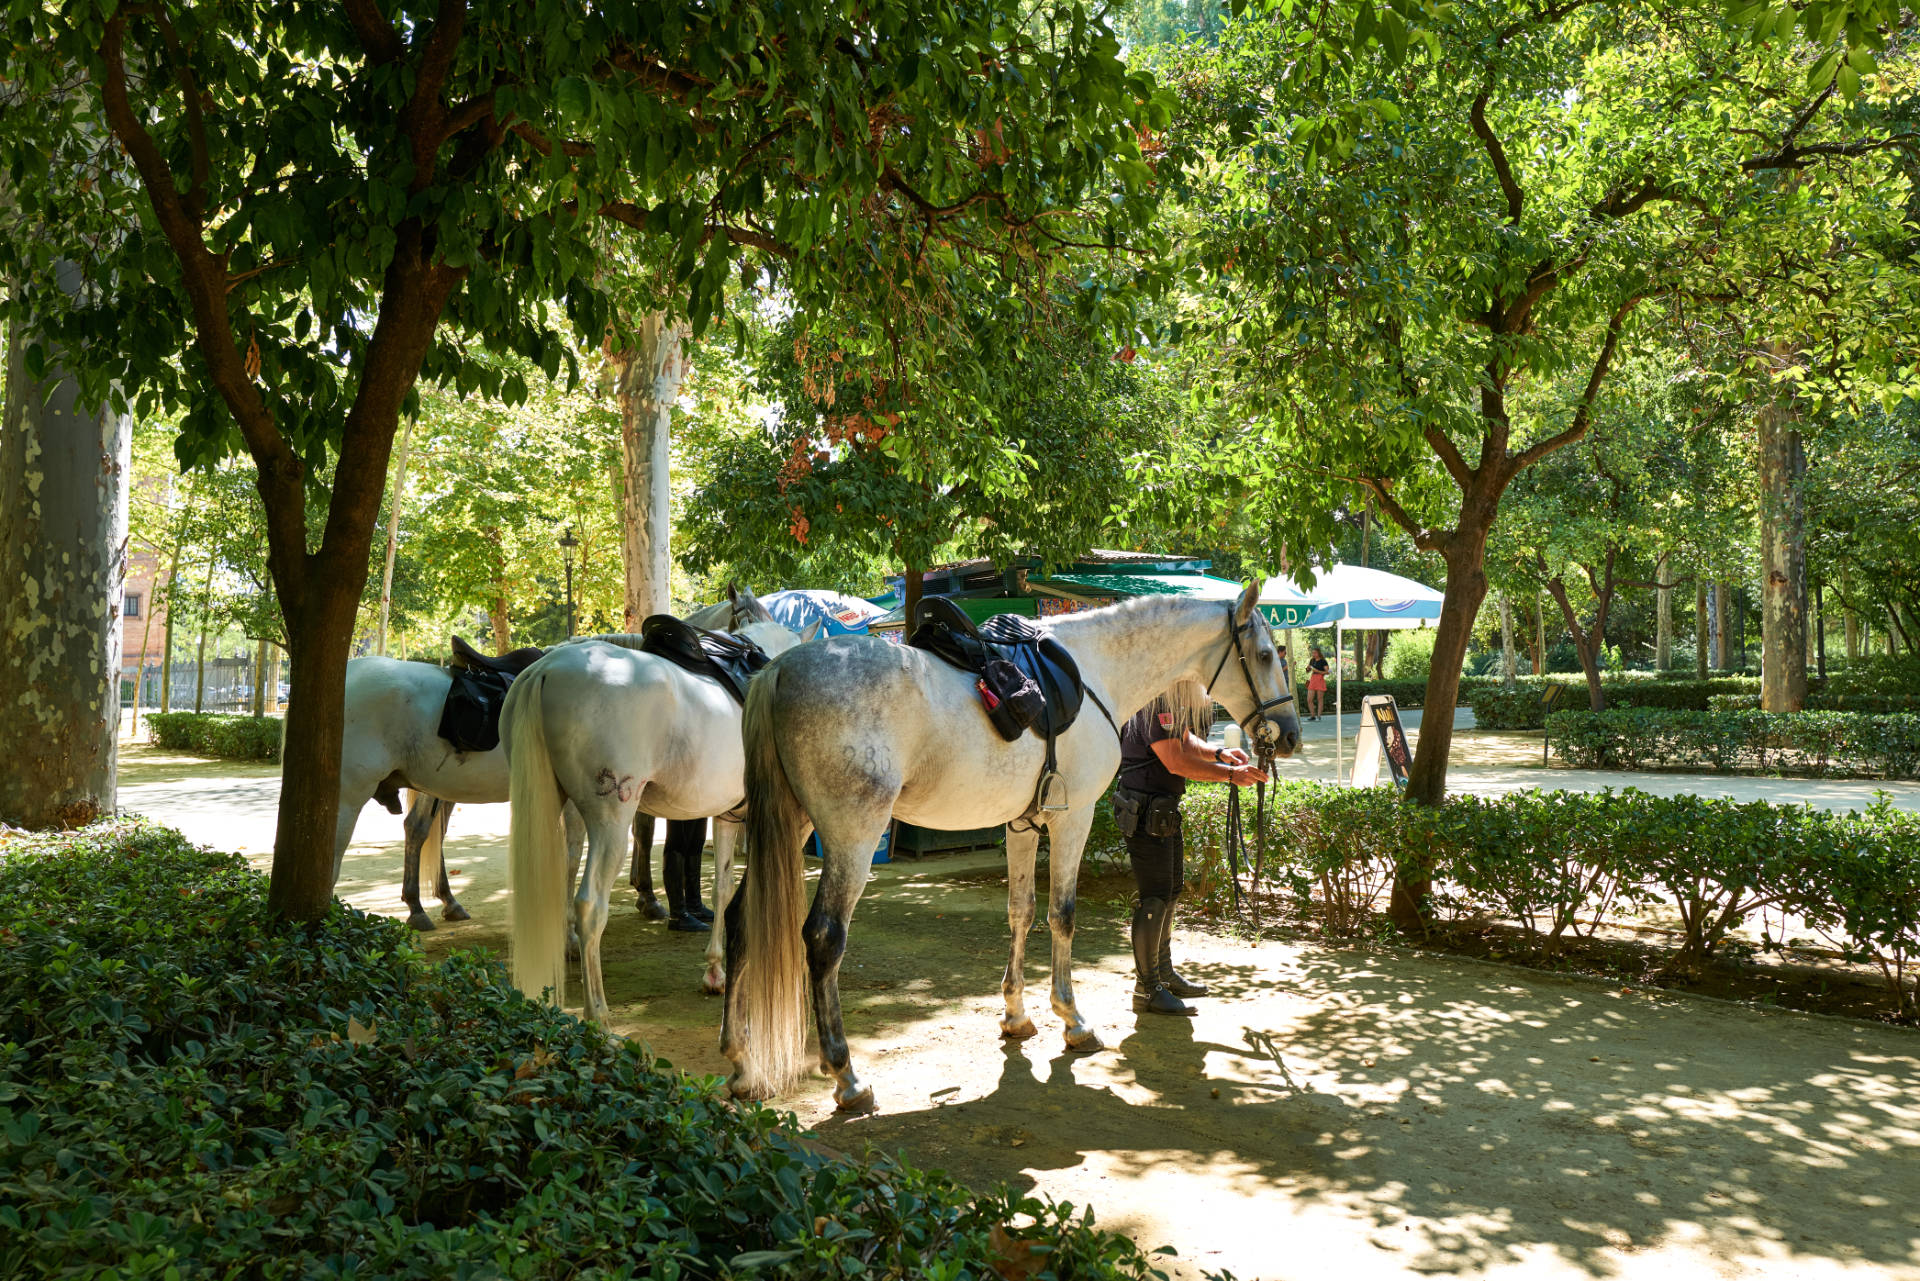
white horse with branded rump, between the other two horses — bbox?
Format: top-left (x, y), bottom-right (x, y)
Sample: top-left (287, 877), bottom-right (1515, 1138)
top-left (501, 620), bottom-right (818, 1026)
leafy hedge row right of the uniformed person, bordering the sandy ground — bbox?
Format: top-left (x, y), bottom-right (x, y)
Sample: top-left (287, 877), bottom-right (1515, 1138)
top-left (1185, 784), bottom-right (1920, 1018)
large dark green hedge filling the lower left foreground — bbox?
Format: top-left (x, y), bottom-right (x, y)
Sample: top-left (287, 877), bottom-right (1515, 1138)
top-left (0, 822), bottom-right (1150, 1281)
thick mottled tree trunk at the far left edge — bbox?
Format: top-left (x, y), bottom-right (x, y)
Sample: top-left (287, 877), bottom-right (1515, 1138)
top-left (0, 305), bottom-right (132, 828)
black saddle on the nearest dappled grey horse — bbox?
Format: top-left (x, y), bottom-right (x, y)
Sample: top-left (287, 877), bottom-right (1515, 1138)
top-left (906, 595), bottom-right (1119, 810)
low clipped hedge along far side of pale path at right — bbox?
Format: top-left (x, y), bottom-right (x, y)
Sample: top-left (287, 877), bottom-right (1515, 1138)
top-left (1548, 707), bottom-right (1920, 778)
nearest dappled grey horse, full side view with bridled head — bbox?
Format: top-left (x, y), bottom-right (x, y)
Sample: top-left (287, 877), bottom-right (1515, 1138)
top-left (720, 584), bottom-right (1300, 1112)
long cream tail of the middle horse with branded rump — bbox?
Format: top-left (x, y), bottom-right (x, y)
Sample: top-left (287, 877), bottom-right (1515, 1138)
top-left (501, 672), bottom-right (566, 1004)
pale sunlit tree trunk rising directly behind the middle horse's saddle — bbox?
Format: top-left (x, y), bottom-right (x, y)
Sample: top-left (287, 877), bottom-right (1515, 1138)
top-left (609, 313), bottom-right (687, 632)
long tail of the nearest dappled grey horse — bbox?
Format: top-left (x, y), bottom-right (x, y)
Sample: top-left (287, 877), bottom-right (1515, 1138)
top-left (728, 666), bottom-right (806, 1099)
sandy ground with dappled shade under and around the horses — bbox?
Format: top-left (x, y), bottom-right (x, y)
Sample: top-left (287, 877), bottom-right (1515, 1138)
top-left (121, 741), bottom-right (1920, 1281)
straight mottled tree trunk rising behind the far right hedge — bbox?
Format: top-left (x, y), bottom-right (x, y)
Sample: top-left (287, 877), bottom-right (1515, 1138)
top-left (1741, 372), bottom-right (1807, 713)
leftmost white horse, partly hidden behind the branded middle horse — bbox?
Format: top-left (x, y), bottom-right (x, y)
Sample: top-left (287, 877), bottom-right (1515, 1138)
top-left (334, 586), bottom-right (771, 930)
